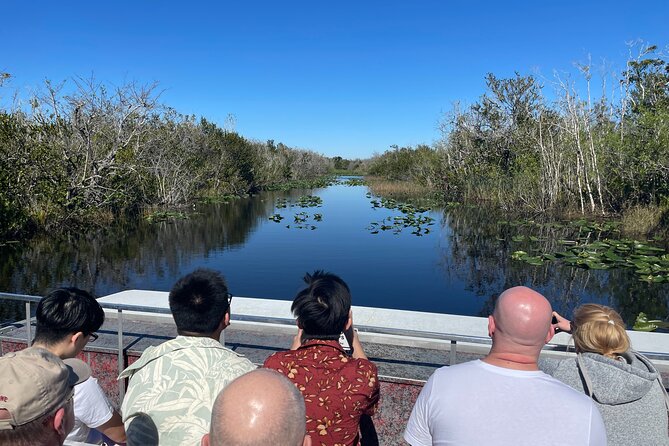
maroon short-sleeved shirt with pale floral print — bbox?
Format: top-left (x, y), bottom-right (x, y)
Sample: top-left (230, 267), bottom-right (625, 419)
top-left (263, 340), bottom-right (379, 446)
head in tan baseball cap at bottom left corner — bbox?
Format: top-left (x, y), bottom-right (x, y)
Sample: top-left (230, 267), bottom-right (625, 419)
top-left (0, 348), bottom-right (89, 446)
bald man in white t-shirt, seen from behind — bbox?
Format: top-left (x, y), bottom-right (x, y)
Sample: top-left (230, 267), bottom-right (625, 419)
top-left (404, 287), bottom-right (606, 446)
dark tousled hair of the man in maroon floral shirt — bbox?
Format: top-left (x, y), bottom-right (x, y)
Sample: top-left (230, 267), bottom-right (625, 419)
top-left (290, 270), bottom-right (351, 339)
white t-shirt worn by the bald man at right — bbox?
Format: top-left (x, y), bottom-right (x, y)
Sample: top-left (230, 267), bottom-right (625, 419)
top-left (404, 360), bottom-right (606, 446)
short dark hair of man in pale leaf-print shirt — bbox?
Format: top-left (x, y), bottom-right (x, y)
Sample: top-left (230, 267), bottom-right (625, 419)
top-left (170, 268), bottom-right (230, 334)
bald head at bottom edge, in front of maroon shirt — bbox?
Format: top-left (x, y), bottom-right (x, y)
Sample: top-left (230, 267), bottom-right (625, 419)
top-left (202, 369), bottom-right (311, 446)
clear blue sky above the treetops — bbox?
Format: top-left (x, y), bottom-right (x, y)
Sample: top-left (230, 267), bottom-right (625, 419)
top-left (0, 0), bottom-right (669, 158)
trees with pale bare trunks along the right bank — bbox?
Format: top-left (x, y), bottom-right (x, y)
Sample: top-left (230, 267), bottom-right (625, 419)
top-left (369, 45), bottom-right (669, 220)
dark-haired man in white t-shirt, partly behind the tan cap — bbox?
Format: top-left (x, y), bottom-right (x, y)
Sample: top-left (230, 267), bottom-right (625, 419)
top-left (33, 287), bottom-right (125, 443)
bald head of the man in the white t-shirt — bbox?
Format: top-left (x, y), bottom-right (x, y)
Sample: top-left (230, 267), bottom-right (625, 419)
top-left (493, 286), bottom-right (552, 349)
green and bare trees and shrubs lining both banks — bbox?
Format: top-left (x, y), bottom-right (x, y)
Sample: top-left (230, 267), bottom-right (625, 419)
top-left (0, 42), bottom-right (669, 240)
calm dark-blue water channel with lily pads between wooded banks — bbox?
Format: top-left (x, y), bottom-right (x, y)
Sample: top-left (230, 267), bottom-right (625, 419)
top-left (0, 179), bottom-right (669, 324)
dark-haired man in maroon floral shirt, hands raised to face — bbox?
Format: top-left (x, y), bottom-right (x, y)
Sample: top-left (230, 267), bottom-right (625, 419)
top-left (264, 271), bottom-right (379, 446)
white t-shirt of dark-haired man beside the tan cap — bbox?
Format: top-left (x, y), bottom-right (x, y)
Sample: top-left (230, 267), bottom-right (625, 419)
top-left (67, 377), bottom-right (114, 443)
